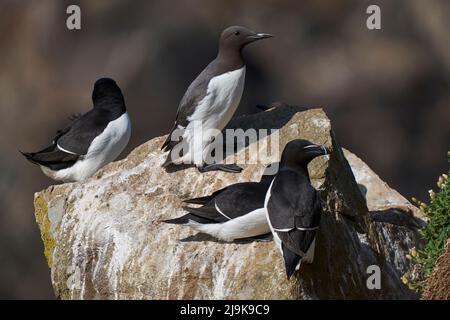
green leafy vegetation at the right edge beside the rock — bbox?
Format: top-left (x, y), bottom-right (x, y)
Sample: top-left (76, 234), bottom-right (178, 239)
top-left (402, 151), bottom-right (450, 291)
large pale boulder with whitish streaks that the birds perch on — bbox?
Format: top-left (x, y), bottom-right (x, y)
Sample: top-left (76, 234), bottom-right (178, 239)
top-left (35, 106), bottom-right (421, 299)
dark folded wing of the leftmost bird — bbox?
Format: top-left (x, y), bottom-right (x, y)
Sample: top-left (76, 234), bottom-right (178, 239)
top-left (56, 108), bottom-right (117, 155)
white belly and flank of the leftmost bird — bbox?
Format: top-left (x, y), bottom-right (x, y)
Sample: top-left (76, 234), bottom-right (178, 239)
top-left (41, 113), bottom-right (131, 182)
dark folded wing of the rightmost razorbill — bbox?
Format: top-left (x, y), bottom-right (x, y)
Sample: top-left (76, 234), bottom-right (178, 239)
top-left (267, 170), bottom-right (322, 256)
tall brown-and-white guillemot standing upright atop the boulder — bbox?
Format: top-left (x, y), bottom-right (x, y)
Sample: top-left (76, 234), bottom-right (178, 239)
top-left (161, 26), bottom-right (272, 172)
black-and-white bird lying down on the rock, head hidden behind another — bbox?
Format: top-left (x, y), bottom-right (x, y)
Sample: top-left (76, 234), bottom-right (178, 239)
top-left (164, 171), bottom-right (274, 241)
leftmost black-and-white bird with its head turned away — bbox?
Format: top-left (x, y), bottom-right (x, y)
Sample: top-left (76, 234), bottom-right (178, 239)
top-left (22, 78), bottom-right (131, 182)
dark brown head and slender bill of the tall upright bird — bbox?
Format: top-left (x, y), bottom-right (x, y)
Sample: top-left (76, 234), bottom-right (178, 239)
top-left (219, 26), bottom-right (272, 54)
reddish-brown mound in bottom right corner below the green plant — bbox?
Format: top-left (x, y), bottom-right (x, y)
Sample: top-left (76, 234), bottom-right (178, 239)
top-left (422, 238), bottom-right (450, 300)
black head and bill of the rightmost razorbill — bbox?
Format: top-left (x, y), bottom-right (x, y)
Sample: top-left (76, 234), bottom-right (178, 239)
top-left (281, 139), bottom-right (330, 169)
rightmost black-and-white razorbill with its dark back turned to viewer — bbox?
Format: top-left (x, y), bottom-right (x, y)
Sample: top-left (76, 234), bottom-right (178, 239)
top-left (264, 140), bottom-right (329, 279)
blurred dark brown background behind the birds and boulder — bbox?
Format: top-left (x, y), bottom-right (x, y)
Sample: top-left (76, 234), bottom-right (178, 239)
top-left (0, 0), bottom-right (450, 299)
